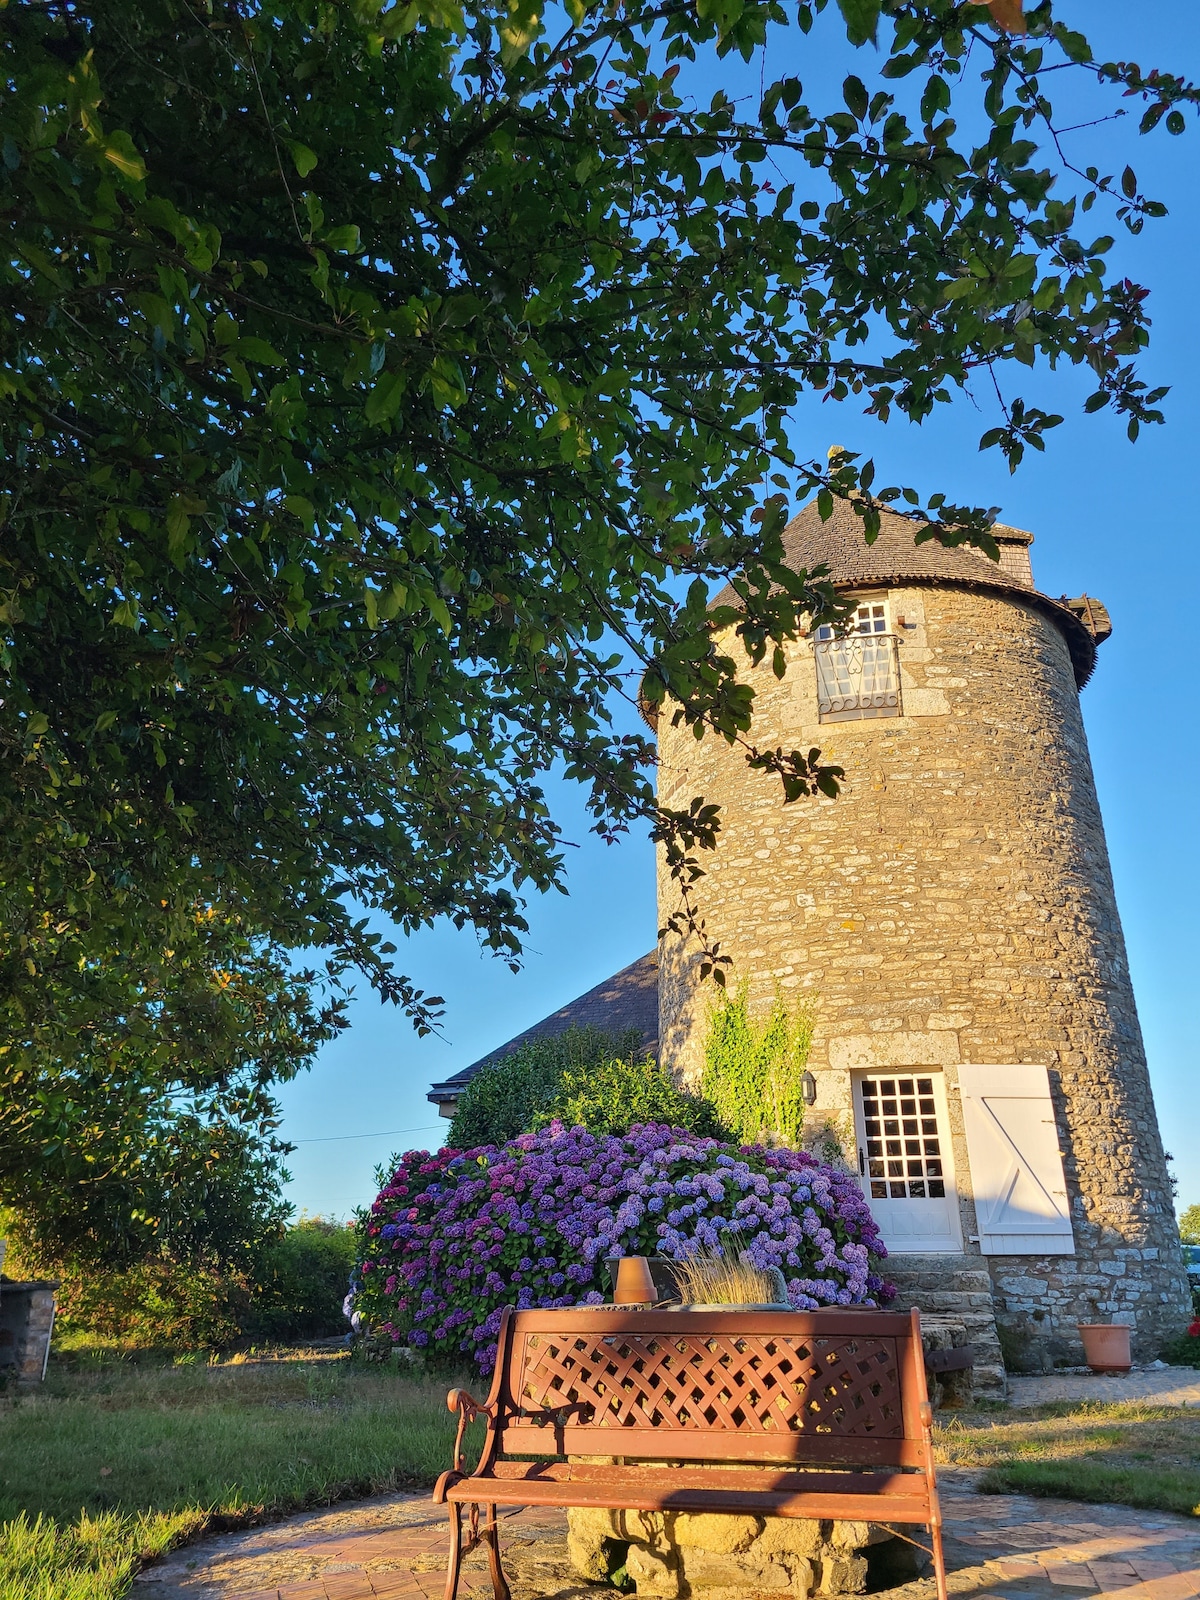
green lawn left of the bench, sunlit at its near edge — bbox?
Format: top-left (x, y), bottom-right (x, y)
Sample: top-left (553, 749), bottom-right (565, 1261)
top-left (0, 1354), bottom-right (480, 1600)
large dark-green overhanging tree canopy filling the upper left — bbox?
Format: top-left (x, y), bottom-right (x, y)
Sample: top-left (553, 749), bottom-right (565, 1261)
top-left (0, 0), bottom-right (1197, 1248)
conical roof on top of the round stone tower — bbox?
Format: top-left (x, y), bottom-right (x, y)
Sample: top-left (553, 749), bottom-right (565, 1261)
top-left (714, 499), bottom-right (1096, 688)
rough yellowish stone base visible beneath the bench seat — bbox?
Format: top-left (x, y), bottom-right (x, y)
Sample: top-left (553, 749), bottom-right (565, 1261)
top-left (566, 1509), bottom-right (917, 1600)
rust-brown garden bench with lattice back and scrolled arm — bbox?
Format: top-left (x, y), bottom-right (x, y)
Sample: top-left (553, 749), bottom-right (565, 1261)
top-left (434, 1306), bottom-right (946, 1600)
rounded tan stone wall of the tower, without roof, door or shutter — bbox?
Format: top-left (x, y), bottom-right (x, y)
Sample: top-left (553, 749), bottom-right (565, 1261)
top-left (659, 586), bottom-right (1187, 1355)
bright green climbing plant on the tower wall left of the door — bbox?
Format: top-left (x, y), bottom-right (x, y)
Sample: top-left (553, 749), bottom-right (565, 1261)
top-left (701, 982), bottom-right (814, 1146)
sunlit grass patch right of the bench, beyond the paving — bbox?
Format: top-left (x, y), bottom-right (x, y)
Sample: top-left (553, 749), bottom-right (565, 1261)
top-left (938, 1403), bottom-right (1200, 1517)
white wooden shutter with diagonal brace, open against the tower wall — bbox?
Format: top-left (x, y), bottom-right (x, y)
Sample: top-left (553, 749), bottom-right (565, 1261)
top-left (958, 1062), bottom-right (1075, 1256)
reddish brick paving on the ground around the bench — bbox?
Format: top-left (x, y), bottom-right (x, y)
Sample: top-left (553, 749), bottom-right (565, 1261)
top-left (134, 1469), bottom-right (1200, 1600)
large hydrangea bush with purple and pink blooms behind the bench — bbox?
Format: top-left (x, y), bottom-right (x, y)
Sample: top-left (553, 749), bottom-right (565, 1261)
top-left (355, 1123), bottom-right (894, 1373)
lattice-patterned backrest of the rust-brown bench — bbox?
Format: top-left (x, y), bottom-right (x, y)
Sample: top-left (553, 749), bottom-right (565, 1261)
top-left (493, 1307), bottom-right (923, 1466)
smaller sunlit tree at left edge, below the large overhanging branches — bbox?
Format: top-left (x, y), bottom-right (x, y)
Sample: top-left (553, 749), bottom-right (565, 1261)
top-left (0, 907), bottom-right (342, 1267)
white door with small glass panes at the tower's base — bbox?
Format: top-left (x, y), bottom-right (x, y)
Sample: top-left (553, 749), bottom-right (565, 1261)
top-left (854, 1069), bottom-right (963, 1254)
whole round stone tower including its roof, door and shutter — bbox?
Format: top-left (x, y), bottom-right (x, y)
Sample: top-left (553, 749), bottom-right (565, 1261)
top-left (659, 504), bottom-right (1189, 1355)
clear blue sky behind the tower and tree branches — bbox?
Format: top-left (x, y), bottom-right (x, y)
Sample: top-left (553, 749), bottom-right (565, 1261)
top-left (280, 0), bottom-right (1200, 1216)
